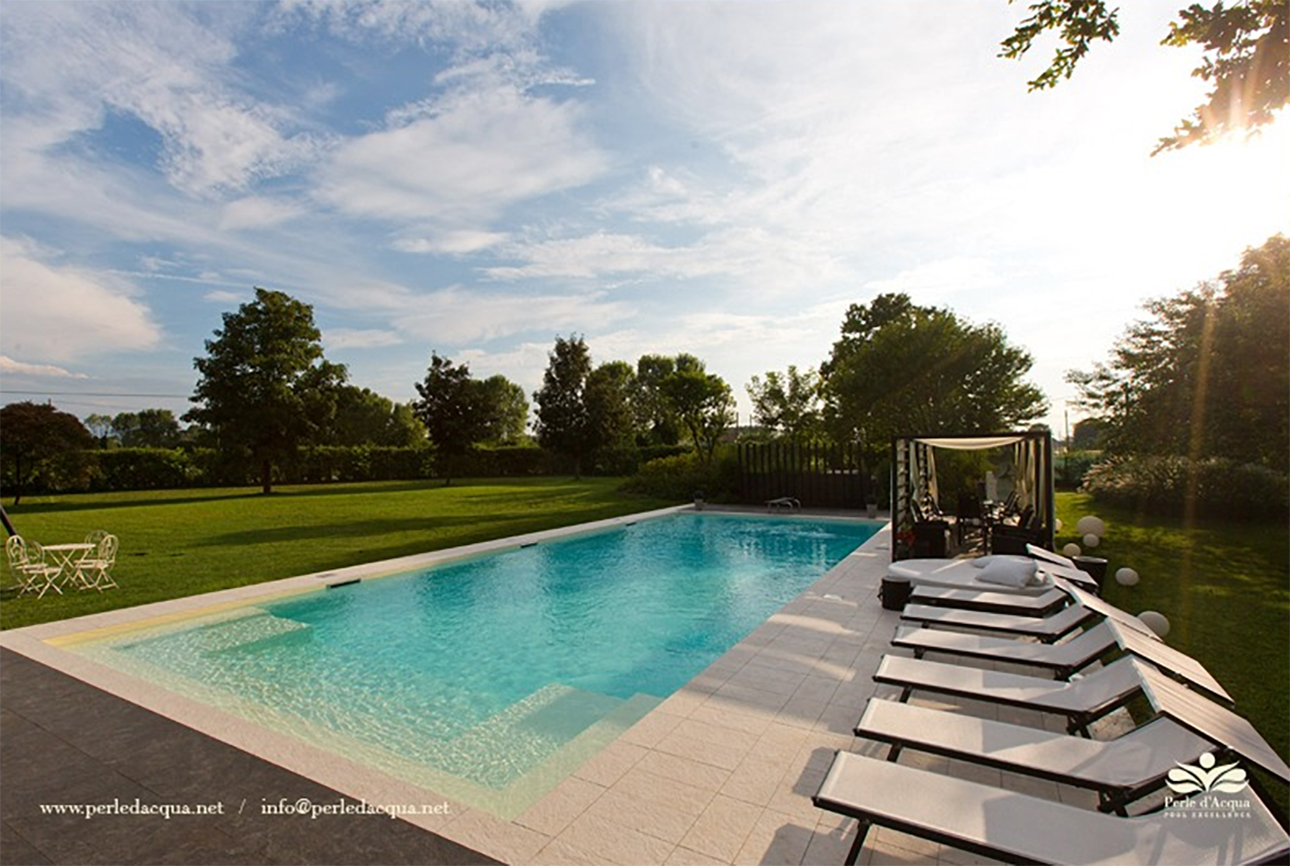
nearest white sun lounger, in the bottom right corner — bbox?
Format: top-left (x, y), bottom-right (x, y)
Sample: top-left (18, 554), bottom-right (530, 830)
top-left (811, 751), bottom-right (1290, 866)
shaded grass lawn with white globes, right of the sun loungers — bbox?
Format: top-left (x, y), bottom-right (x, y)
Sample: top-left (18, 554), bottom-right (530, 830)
top-left (1057, 493), bottom-right (1290, 812)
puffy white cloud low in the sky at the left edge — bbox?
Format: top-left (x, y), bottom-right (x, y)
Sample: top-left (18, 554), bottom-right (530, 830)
top-left (0, 237), bottom-right (161, 363)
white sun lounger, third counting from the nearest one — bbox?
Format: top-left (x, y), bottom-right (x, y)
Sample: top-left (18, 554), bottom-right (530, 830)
top-left (873, 656), bottom-right (1146, 736)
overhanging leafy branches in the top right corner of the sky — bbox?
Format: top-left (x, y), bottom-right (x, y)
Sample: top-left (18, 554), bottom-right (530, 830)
top-left (1000, 0), bottom-right (1290, 154)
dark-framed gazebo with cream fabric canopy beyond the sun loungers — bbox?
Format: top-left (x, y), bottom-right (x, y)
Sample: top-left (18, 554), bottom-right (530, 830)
top-left (891, 430), bottom-right (1054, 560)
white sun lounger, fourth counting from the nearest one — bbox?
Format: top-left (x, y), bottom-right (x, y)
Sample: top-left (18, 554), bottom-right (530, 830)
top-left (891, 619), bottom-right (1120, 680)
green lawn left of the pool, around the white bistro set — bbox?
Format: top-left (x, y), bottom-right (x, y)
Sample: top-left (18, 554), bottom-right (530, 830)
top-left (0, 478), bottom-right (676, 629)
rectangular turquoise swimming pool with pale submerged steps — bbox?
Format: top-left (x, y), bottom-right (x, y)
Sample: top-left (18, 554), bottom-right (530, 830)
top-left (72, 514), bottom-right (880, 817)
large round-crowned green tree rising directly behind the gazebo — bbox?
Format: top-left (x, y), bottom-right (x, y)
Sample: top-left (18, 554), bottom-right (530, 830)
top-left (822, 294), bottom-right (1046, 458)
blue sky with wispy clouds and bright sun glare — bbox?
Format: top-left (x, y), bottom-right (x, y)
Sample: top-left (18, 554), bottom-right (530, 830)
top-left (0, 0), bottom-right (1290, 435)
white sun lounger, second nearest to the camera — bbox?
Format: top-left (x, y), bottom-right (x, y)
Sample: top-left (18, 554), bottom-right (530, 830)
top-left (855, 698), bottom-right (1222, 813)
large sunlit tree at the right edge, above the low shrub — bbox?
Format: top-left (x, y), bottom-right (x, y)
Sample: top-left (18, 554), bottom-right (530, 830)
top-left (1067, 235), bottom-right (1290, 472)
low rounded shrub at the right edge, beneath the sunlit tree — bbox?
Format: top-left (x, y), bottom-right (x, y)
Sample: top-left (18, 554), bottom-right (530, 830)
top-left (1084, 456), bottom-right (1290, 520)
